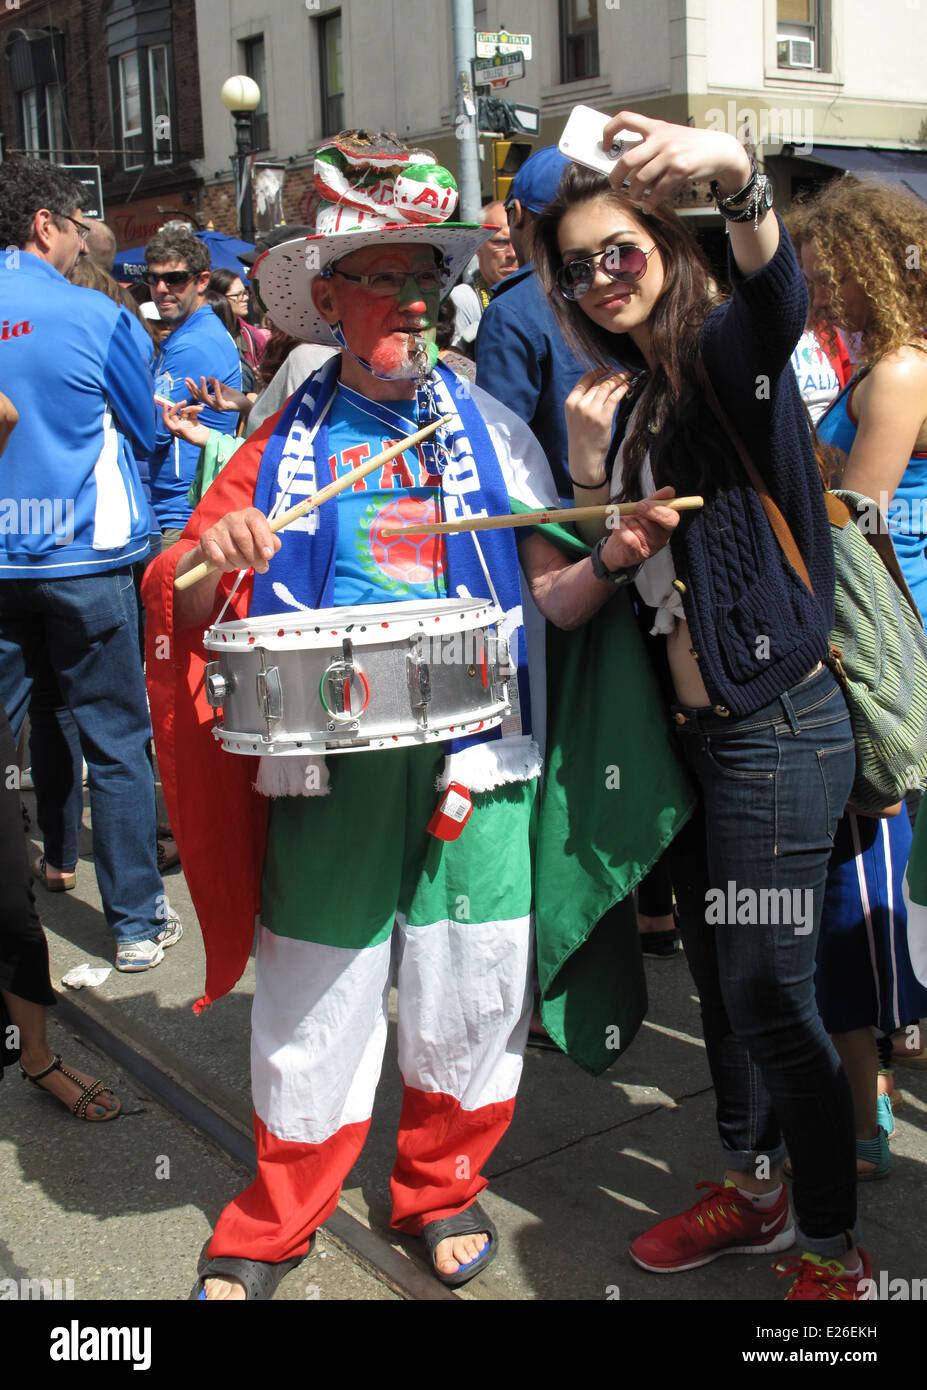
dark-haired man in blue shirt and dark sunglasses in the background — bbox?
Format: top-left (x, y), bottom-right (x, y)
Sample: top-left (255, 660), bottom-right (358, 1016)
top-left (145, 224), bottom-right (242, 545)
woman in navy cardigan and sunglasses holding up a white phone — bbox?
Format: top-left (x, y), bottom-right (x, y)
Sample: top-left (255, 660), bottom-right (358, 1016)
top-left (536, 111), bottom-right (870, 1300)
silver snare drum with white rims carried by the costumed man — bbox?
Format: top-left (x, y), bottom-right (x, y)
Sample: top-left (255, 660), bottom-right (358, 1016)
top-left (203, 599), bottom-right (514, 755)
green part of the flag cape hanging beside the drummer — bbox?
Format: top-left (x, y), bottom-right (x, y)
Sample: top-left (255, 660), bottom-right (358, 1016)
top-left (511, 499), bottom-right (696, 1076)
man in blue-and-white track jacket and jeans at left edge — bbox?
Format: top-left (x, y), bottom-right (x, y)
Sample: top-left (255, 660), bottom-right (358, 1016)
top-left (0, 158), bottom-right (182, 970)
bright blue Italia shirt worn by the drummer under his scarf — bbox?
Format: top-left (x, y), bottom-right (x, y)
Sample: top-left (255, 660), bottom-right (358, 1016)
top-left (325, 385), bottom-right (448, 607)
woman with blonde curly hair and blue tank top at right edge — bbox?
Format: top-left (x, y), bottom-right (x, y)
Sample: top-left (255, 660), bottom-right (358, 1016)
top-left (792, 178), bottom-right (927, 1179)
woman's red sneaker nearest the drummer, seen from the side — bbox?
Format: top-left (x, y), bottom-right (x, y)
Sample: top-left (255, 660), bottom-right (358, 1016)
top-left (631, 1183), bottom-right (795, 1275)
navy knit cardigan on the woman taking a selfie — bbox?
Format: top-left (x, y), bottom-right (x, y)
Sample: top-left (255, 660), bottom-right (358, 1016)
top-left (655, 222), bottom-right (834, 717)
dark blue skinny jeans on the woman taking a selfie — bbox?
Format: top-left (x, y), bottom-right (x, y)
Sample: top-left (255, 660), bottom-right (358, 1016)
top-left (670, 667), bottom-right (856, 1255)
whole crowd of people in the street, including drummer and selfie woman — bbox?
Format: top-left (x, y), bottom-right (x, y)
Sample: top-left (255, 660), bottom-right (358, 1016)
top-left (0, 113), bottom-right (927, 1300)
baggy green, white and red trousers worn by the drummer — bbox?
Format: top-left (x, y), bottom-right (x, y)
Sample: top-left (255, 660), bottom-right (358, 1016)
top-left (208, 746), bottom-right (538, 1261)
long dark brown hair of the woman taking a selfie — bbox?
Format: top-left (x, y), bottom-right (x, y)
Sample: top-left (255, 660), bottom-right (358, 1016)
top-left (535, 164), bottom-right (742, 496)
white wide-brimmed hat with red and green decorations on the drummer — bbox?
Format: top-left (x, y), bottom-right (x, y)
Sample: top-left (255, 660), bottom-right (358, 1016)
top-left (252, 131), bottom-right (499, 346)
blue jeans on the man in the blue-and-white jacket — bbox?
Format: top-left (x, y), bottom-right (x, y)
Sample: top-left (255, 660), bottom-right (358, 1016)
top-left (0, 569), bottom-right (165, 942)
